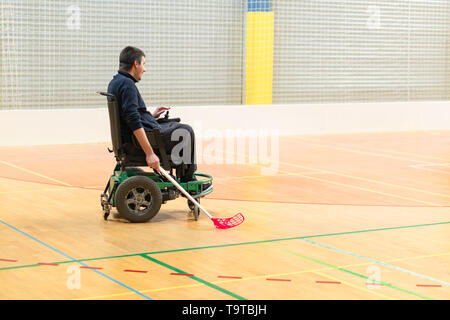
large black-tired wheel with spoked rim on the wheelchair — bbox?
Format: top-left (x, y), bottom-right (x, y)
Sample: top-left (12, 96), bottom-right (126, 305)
top-left (116, 176), bottom-right (162, 222)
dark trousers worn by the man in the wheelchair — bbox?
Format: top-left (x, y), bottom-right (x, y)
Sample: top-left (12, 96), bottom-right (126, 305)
top-left (160, 122), bottom-right (197, 182)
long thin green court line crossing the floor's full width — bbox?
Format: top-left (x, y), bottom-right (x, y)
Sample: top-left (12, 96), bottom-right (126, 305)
top-left (0, 221), bottom-right (450, 271)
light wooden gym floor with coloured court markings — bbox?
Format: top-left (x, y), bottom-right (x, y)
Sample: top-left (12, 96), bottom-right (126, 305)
top-left (0, 131), bottom-right (450, 300)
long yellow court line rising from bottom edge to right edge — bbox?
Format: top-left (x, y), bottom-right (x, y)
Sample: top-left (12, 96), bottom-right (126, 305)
top-left (74, 252), bottom-right (450, 300)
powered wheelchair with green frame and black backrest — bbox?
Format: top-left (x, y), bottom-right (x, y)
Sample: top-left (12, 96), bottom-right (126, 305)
top-left (98, 92), bottom-right (213, 222)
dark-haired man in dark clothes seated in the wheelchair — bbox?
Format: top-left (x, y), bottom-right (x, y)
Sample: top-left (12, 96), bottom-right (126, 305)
top-left (108, 46), bottom-right (200, 184)
